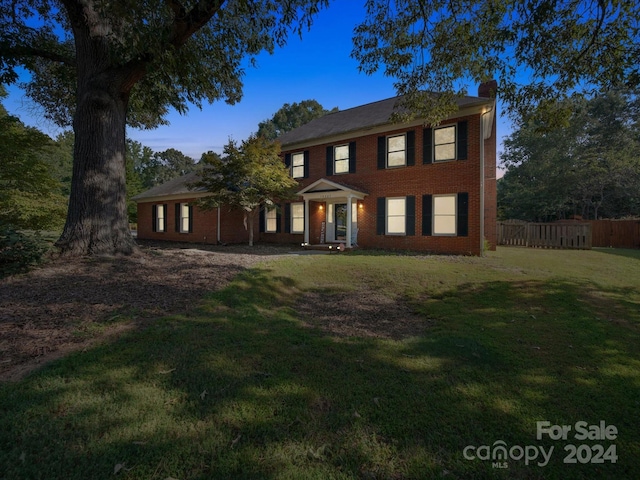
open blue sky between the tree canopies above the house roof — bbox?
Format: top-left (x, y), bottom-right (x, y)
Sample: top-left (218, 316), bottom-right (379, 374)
top-left (4, 0), bottom-right (506, 169)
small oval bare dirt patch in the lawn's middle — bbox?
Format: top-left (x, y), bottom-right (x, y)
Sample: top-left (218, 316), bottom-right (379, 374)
top-left (296, 289), bottom-right (430, 340)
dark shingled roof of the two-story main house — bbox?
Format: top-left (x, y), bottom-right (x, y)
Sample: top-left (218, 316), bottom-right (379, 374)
top-left (277, 96), bottom-right (493, 146)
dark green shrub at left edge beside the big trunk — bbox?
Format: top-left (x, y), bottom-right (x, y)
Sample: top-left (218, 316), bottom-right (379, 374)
top-left (0, 224), bottom-right (49, 278)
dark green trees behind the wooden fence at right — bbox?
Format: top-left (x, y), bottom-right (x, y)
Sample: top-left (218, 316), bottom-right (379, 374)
top-left (498, 92), bottom-right (640, 221)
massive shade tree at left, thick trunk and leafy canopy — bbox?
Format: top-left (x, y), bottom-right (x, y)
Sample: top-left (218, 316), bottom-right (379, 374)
top-left (0, 0), bottom-right (328, 255)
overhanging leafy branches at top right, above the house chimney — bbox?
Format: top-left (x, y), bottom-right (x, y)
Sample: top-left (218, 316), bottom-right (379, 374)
top-left (352, 0), bottom-right (640, 126)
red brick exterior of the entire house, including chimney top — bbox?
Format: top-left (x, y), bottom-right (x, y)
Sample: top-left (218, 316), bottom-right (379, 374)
top-left (138, 88), bottom-right (497, 255)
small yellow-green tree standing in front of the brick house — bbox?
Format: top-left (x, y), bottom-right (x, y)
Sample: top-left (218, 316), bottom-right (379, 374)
top-left (191, 136), bottom-right (298, 246)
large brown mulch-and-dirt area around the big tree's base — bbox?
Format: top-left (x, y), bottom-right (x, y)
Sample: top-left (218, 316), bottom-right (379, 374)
top-left (0, 242), bottom-right (292, 381)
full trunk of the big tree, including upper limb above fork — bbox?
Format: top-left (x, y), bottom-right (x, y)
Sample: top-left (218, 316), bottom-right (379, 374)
top-left (56, 5), bottom-right (141, 256)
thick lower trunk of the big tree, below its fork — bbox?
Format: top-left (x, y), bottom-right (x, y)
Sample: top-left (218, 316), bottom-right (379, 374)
top-left (56, 80), bottom-right (136, 256)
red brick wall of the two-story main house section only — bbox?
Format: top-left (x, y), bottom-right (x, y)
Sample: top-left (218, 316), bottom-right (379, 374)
top-left (274, 115), bottom-right (496, 255)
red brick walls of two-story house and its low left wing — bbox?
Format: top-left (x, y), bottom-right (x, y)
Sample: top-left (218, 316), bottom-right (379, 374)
top-left (138, 109), bottom-right (497, 255)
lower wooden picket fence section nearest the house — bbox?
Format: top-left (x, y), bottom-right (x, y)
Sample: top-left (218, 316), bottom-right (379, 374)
top-left (498, 220), bottom-right (591, 250)
